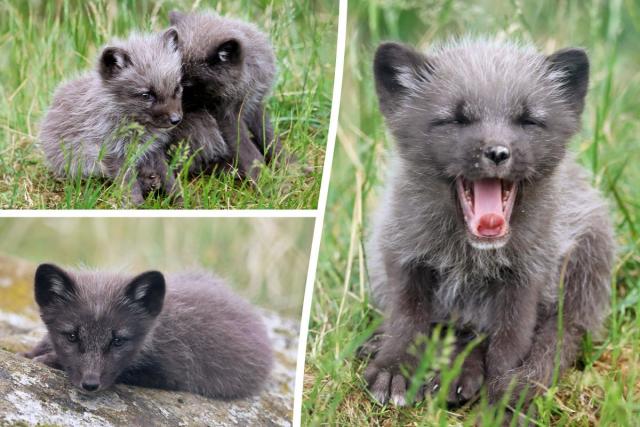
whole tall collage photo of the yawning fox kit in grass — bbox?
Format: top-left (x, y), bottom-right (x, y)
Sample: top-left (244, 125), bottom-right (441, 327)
top-left (301, 0), bottom-right (640, 426)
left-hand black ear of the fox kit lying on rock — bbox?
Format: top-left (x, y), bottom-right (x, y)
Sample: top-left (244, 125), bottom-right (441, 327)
top-left (34, 264), bottom-right (76, 307)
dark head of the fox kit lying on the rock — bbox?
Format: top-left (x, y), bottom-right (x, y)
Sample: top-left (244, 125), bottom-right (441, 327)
top-left (35, 264), bottom-right (165, 392)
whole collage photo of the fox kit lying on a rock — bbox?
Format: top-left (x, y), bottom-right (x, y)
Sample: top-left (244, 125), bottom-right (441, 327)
top-left (0, 217), bottom-right (314, 425)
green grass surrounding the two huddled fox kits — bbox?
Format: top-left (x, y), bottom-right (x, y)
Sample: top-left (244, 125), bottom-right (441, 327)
top-left (0, 0), bottom-right (338, 209)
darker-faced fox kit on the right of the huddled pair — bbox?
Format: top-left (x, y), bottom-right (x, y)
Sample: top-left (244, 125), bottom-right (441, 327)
top-left (170, 11), bottom-right (281, 180)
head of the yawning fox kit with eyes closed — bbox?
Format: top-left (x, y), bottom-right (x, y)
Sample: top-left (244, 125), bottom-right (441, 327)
top-left (373, 40), bottom-right (589, 249)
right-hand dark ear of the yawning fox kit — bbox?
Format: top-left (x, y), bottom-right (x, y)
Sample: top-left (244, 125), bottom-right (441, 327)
top-left (547, 48), bottom-right (589, 115)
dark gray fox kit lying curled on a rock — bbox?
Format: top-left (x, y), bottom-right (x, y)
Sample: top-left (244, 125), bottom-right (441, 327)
top-left (27, 264), bottom-right (272, 398)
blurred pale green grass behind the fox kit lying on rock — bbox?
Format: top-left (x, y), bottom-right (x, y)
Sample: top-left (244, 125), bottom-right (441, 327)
top-left (0, 218), bottom-right (314, 318)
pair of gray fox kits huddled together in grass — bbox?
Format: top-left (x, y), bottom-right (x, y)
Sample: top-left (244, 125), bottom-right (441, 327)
top-left (39, 11), bottom-right (281, 204)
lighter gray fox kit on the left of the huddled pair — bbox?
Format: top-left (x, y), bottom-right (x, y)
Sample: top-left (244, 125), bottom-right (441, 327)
top-left (39, 28), bottom-right (182, 204)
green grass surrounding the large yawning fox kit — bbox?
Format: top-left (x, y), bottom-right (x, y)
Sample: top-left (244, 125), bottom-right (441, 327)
top-left (302, 0), bottom-right (640, 426)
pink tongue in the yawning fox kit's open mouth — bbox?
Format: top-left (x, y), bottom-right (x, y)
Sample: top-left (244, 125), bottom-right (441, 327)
top-left (473, 179), bottom-right (506, 237)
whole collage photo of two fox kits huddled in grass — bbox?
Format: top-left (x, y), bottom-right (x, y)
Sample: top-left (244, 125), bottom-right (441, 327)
top-left (0, 0), bottom-right (338, 209)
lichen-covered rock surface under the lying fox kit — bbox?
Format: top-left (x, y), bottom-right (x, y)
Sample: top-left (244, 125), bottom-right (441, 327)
top-left (0, 257), bottom-right (298, 426)
